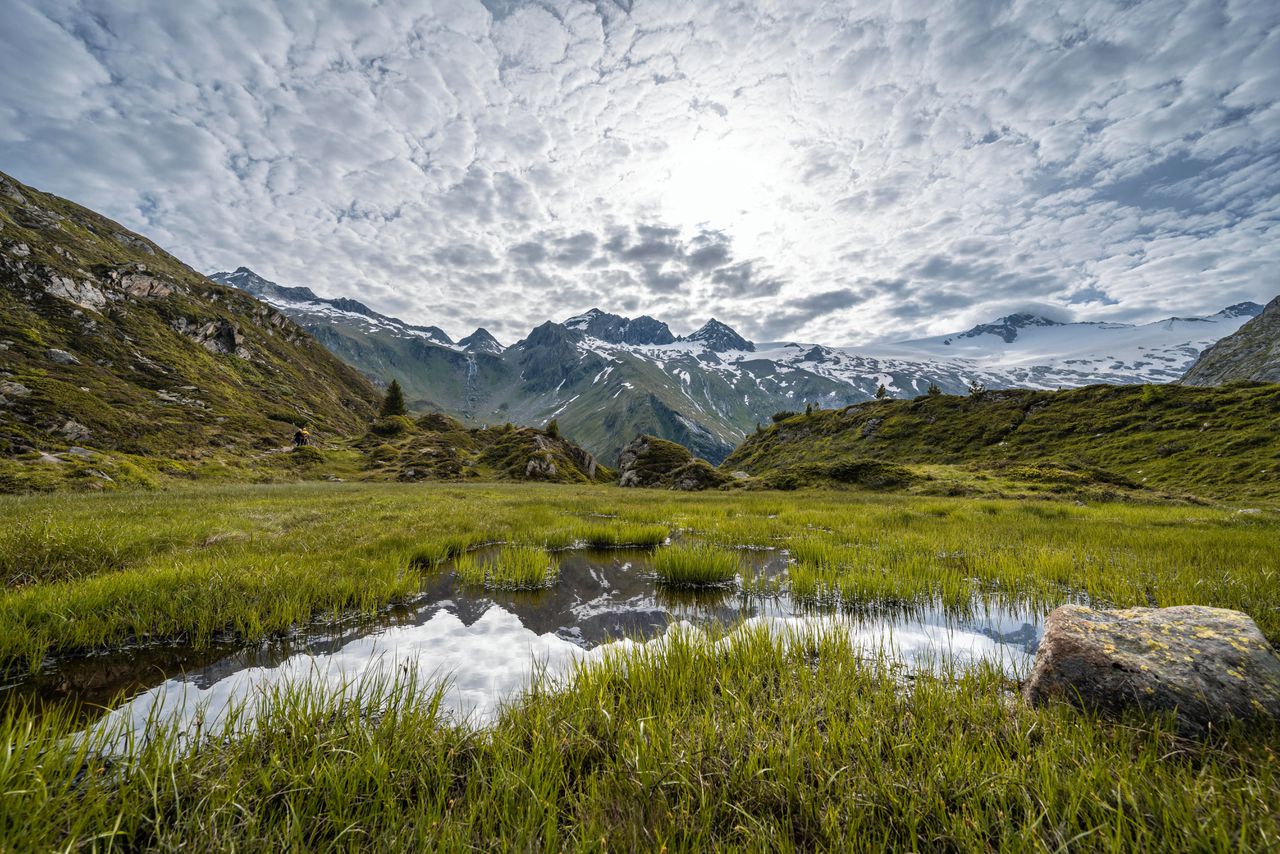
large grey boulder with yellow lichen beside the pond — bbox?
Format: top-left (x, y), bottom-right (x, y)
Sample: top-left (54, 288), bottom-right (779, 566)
top-left (1024, 604), bottom-right (1280, 735)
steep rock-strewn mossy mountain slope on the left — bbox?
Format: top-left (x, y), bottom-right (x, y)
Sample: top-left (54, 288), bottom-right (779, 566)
top-left (0, 174), bottom-right (378, 458)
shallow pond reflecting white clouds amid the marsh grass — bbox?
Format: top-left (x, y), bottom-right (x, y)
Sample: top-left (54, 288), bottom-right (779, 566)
top-left (0, 549), bottom-right (1043, 729)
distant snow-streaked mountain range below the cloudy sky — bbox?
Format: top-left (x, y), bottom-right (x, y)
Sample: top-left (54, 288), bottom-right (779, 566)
top-left (210, 268), bottom-right (1262, 465)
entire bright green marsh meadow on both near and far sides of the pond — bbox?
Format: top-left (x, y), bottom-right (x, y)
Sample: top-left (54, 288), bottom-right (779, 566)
top-left (0, 484), bottom-right (1280, 850)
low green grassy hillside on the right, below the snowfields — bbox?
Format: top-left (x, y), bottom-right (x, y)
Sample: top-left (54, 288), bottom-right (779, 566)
top-left (723, 384), bottom-right (1280, 499)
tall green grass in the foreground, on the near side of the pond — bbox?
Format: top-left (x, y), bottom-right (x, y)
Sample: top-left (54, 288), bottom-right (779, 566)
top-left (0, 631), bottom-right (1280, 851)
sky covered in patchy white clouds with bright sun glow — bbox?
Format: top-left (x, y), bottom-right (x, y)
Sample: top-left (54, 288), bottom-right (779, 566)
top-left (0, 0), bottom-right (1280, 343)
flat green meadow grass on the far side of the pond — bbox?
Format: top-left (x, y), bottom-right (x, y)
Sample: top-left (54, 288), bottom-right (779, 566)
top-left (0, 484), bottom-right (1280, 671)
